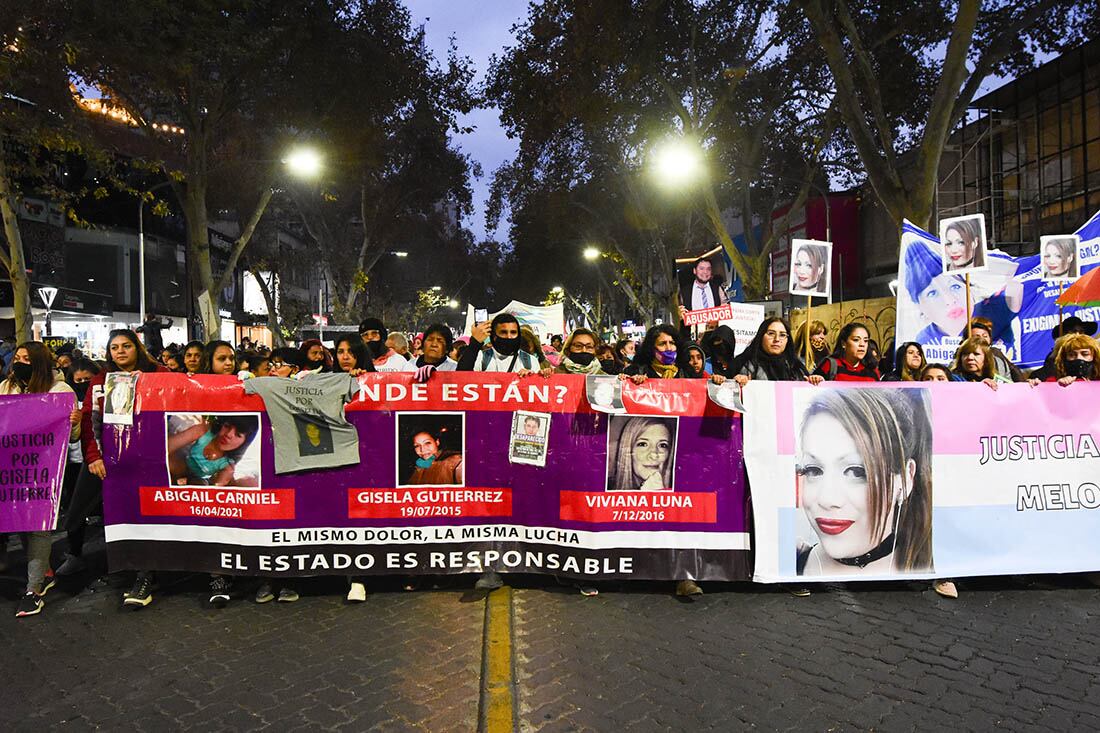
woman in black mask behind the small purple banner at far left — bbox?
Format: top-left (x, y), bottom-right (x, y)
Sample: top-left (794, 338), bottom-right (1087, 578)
top-left (0, 341), bottom-right (80, 616)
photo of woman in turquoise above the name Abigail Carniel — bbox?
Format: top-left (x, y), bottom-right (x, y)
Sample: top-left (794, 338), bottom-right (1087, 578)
top-left (165, 413), bottom-right (260, 486)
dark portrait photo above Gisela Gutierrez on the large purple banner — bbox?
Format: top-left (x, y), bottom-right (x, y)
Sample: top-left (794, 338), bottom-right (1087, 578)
top-left (397, 413), bottom-right (465, 486)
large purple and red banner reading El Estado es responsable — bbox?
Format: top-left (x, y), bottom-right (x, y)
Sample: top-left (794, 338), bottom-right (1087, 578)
top-left (103, 373), bottom-right (750, 580)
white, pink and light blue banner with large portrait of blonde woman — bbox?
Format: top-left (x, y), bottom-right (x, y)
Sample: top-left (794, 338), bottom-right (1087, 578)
top-left (744, 382), bottom-right (1100, 582)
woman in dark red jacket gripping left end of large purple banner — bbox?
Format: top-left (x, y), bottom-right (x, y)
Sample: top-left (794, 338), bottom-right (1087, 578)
top-left (57, 328), bottom-right (168, 609)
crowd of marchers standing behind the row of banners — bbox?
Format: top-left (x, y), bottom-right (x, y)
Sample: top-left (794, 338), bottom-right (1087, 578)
top-left (0, 303), bottom-right (1100, 616)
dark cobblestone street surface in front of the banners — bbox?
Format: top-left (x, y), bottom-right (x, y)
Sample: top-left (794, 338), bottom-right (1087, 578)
top-left (0, 534), bottom-right (1100, 731)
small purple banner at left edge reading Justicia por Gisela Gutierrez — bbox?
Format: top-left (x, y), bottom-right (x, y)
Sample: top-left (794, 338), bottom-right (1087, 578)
top-left (0, 393), bottom-right (75, 533)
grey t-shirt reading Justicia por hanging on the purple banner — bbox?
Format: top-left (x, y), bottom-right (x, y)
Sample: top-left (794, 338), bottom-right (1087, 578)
top-left (244, 372), bottom-right (359, 473)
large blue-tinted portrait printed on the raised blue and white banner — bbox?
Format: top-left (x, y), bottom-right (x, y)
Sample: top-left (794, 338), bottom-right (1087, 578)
top-left (904, 240), bottom-right (1023, 351)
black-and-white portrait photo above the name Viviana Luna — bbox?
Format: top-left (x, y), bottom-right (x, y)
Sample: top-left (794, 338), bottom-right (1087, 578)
top-left (607, 415), bottom-right (677, 491)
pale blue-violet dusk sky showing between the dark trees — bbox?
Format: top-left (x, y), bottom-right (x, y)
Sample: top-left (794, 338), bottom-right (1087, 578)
top-left (405, 0), bottom-right (528, 240)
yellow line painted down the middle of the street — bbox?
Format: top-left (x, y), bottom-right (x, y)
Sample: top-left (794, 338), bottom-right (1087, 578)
top-left (477, 586), bottom-right (518, 733)
